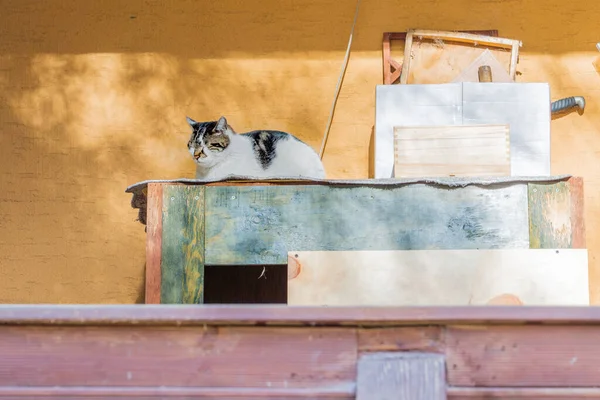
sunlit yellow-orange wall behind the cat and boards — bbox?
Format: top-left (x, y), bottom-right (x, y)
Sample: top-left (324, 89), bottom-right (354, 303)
top-left (0, 0), bottom-right (600, 303)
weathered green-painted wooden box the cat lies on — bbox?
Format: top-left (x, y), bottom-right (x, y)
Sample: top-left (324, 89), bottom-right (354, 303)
top-left (127, 177), bottom-right (585, 304)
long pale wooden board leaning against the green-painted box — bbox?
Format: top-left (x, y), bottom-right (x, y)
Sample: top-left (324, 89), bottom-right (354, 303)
top-left (288, 249), bottom-right (589, 306)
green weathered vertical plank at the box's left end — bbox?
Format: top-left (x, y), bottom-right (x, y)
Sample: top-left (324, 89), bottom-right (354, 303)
top-left (161, 185), bottom-right (205, 304)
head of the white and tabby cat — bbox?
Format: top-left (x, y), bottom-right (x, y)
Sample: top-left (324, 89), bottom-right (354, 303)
top-left (186, 117), bottom-right (234, 168)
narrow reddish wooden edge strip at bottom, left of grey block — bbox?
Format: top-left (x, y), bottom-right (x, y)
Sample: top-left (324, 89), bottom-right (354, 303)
top-left (0, 383), bottom-right (355, 399)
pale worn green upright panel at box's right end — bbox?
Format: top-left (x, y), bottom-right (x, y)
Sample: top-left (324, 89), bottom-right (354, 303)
top-left (527, 182), bottom-right (572, 249)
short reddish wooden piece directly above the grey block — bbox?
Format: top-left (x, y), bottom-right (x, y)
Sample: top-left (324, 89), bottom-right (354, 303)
top-left (358, 326), bottom-right (445, 353)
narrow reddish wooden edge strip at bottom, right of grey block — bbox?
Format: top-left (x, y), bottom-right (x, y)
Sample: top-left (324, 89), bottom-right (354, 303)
top-left (446, 386), bottom-right (600, 400)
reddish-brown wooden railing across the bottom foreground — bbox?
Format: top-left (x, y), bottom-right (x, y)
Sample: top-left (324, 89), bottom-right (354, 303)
top-left (0, 305), bottom-right (600, 400)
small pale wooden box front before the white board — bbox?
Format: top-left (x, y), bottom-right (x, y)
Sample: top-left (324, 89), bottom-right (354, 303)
top-left (394, 124), bottom-right (510, 178)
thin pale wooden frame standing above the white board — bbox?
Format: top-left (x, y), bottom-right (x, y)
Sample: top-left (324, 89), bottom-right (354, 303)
top-left (400, 29), bottom-right (523, 84)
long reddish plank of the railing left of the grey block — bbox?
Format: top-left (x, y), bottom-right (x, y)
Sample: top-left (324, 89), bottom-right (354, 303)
top-left (0, 326), bottom-right (357, 391)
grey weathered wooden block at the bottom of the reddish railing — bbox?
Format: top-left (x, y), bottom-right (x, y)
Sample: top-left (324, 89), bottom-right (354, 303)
top-left (356, 352), bottom-right (446, 400)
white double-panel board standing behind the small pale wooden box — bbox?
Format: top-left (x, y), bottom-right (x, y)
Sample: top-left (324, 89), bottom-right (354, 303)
top-left (374, 82), bottom-right (550, 179)
